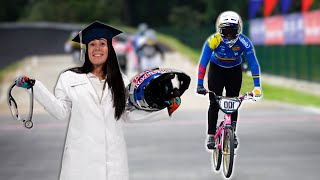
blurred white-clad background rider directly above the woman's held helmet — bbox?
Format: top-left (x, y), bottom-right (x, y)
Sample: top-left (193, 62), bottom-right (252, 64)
top-left (137, 29), bottom-right (164, 71)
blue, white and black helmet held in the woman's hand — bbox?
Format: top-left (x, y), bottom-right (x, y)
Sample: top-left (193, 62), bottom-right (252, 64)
top-left (128, 68), bottom-right (191, 111)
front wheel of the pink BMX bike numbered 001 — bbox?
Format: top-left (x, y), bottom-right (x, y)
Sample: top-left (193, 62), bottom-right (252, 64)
top-left (223, 128), bottom-right (234, 178)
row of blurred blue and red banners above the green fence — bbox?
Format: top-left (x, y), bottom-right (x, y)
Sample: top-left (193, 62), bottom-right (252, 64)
top-left (249, 10), bottom-right (320, 45)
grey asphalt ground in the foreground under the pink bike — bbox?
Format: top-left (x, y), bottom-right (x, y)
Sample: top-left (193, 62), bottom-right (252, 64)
top-left (0, 104), bottom-right (320, 180)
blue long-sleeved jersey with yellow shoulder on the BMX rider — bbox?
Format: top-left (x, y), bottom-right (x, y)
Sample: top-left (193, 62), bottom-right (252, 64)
top-left (198, 33), bottom-right (260, 87)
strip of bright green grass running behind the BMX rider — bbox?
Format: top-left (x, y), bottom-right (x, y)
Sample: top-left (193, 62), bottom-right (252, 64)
top-left (158, 34), bottom-right (320, 107)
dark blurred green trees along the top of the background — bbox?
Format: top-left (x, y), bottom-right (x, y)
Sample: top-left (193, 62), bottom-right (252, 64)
top-left (0, 0), bottom-right (320, 27)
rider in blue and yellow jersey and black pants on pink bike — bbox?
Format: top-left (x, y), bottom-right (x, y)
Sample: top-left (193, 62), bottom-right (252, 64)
top-left (197, 11), bottom-right (262, 149)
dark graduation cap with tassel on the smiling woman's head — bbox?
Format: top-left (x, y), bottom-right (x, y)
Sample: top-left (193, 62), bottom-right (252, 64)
top-left (72, 21), bottom-right (122, 45)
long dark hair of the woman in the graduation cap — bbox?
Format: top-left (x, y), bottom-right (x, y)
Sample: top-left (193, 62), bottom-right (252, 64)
top-left (67, 40), bottom-right (126, 120)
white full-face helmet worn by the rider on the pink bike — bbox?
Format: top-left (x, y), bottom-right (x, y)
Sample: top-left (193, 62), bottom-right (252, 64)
top-left (216, 11), bottom-right (242, 47)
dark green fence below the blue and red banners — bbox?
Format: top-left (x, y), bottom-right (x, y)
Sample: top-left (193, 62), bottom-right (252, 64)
top-left (255, 45), bottom-right (320, 82)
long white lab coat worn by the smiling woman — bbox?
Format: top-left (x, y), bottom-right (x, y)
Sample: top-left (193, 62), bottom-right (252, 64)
top-left (33, 71), bottom-right (169, 180)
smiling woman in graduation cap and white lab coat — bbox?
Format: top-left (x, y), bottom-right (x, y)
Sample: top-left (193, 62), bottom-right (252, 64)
top-left (16, 21), bottom-right (178, 180)
